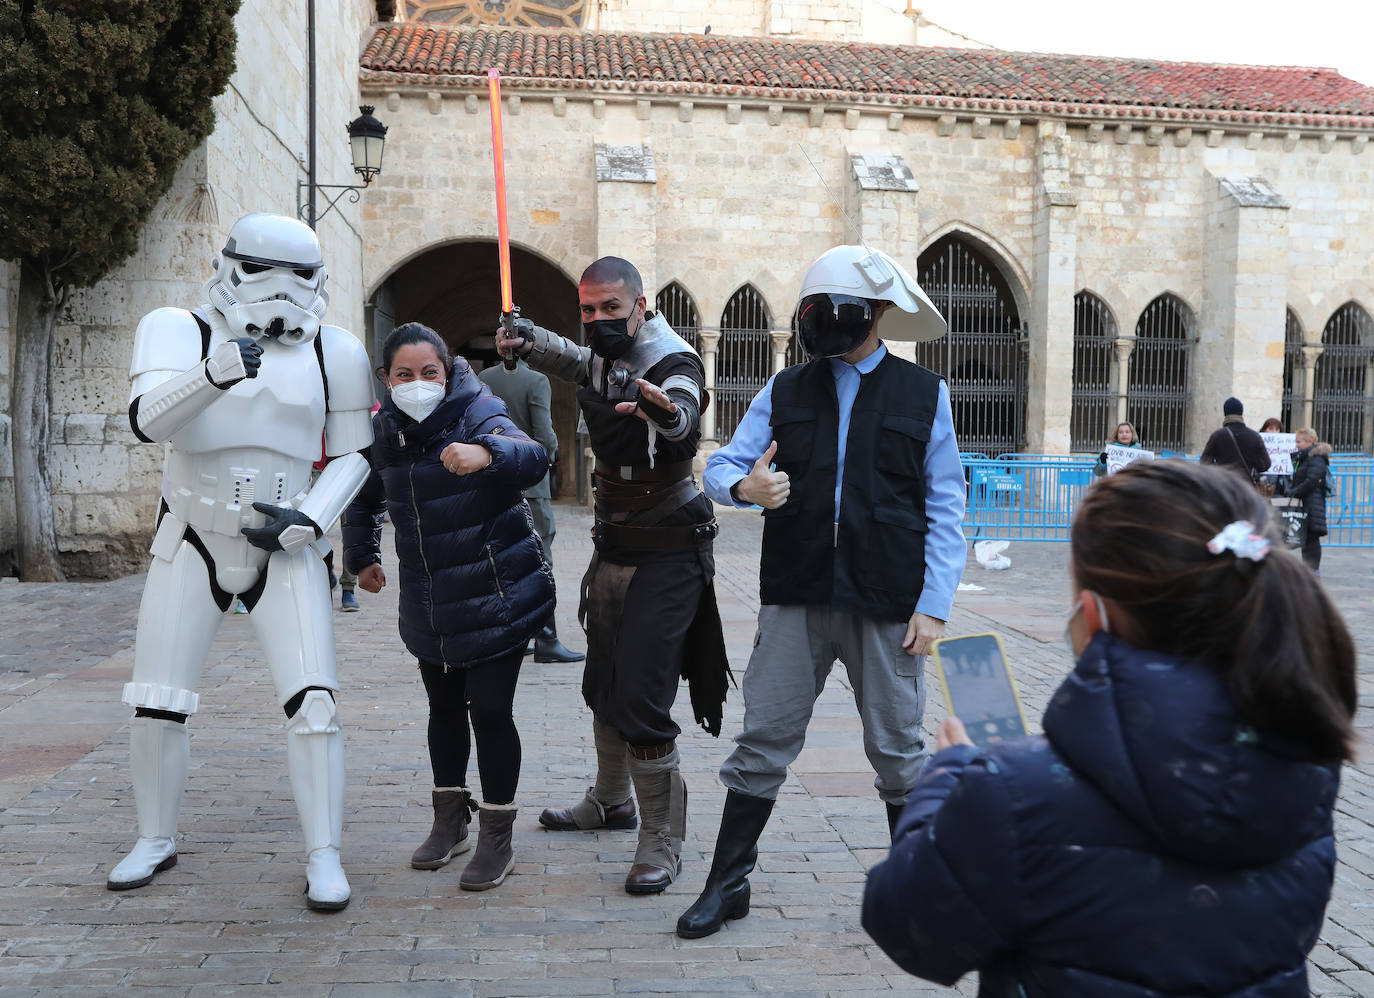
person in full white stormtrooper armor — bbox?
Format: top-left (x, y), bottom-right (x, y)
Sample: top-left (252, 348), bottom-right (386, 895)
top-left (107, 214), bottom-right (372, 910)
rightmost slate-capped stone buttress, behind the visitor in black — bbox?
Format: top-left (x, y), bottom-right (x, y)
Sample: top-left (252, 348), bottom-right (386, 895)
top-left (1187, 176), bottom-right (1289, 452)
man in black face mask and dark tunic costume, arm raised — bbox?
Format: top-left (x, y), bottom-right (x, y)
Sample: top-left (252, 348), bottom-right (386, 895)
top-left (496, 257), bottom-right (728, 894)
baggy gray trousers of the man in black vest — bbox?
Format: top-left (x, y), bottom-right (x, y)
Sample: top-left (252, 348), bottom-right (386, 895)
top-left (720, 606), bottom-right (926, 804)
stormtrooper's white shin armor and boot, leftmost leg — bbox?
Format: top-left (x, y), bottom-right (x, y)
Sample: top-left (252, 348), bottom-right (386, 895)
top-left (106, 718), bottom-right (191, 891)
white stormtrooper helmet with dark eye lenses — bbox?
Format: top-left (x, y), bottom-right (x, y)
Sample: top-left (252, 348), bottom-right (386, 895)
top-left (205, 213), bottom-right (330, 345)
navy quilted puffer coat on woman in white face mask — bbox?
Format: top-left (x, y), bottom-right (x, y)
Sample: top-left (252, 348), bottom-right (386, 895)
top-left (344, 357), bottom-right (554, 667)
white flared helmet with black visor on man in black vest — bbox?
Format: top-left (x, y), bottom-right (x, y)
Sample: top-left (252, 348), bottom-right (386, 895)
top-left (797, 246), bottom-right (948, 356)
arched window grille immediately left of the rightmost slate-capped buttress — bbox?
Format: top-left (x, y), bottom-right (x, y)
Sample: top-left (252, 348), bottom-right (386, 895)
top-left (1125, 294), bottom-right (1194, 451)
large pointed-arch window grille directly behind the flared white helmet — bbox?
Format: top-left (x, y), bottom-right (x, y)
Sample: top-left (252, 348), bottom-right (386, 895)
top-left (916, 235), bottom-right (1026, 454)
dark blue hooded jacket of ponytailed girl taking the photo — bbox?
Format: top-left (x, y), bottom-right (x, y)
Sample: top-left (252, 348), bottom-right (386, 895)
top-left (863, 632), bottom-right (1340, 998)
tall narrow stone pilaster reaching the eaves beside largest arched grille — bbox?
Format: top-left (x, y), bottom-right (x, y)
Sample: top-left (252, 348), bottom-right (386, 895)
top-left (1026, 121), bottom-right (1079, 454)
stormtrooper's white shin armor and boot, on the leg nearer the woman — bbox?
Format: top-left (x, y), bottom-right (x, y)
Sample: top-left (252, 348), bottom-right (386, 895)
top-left (286, 690), bottom-right (349, 911)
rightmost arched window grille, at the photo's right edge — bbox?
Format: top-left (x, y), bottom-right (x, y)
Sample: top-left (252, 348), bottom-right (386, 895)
top-left (1312, 301), bottom-right (1374, 452)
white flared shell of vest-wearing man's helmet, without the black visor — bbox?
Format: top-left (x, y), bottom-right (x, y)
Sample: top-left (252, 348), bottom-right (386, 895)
top-left (798, 246), bottom-right (948, 342)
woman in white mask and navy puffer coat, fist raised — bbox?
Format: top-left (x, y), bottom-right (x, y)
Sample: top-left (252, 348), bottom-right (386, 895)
top-left (344, 323), bottom-right (554, 891)
